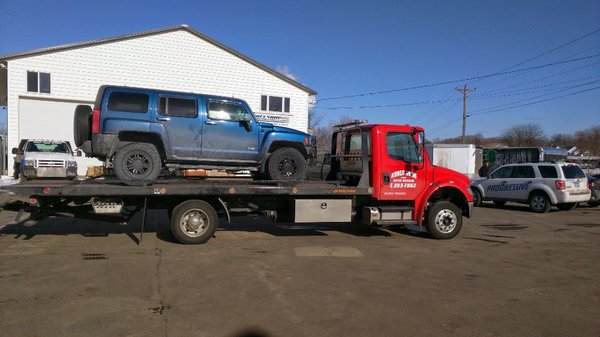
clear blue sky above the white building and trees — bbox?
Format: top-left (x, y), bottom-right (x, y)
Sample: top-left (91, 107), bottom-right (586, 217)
top-left (0, 0), bottom-right (600, 139)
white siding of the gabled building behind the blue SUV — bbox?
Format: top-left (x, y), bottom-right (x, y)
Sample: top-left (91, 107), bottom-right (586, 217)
top-left (8, 30), bottom-right (309, 175)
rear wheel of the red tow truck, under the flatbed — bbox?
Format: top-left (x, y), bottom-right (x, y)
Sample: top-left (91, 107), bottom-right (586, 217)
top-left (171, 200), bottom-right (219, 244)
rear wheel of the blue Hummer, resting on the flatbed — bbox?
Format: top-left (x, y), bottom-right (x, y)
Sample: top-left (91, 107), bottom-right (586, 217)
top-left (113, 143), bottom-right (162, 186)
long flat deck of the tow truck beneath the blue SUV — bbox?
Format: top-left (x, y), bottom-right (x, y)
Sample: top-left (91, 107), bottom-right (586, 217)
top-left (4, 178), bottom-right (372, 197)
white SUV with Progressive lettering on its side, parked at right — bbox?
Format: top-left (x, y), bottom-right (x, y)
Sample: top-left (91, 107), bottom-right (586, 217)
top-left (471, 163), bottom-right (590, 213)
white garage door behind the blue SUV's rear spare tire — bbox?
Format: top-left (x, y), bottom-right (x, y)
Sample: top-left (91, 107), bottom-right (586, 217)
top-left (19, 98), bottom-right (102, 175)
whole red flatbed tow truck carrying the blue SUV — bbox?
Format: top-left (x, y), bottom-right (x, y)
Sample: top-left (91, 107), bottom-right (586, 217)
top-left (7, 122), bottom-right (473, 244)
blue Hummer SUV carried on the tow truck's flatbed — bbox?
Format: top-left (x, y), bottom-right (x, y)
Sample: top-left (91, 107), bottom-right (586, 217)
top-left (74, 86), bottom-right (317, 185)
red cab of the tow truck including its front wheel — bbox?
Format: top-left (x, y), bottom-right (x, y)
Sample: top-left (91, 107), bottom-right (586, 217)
top-left (327, 121), bottom-right (473, 239)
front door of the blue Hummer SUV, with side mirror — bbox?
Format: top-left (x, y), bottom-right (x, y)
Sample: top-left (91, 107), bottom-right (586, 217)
top-left (202, 99), bottom-right (260, 162)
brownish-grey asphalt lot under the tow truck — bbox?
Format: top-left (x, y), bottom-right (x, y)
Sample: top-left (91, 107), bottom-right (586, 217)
top-left (0, 197), bottom-right (600, 337)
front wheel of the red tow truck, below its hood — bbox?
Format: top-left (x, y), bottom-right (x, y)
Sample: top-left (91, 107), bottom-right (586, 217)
top-left (425, 201), bottom-right (462, 240)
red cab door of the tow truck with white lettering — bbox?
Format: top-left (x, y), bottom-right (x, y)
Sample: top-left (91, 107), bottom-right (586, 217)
top-left (374, 131), bottom-right (428, 200)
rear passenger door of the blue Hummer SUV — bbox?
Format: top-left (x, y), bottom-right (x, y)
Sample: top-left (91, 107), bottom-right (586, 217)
top-left (156, 95), bottom-right (202, 159)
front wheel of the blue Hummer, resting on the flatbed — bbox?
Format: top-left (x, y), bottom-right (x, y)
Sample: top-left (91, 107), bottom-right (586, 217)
top-left (267, 147), bottom-right (307, 181)
